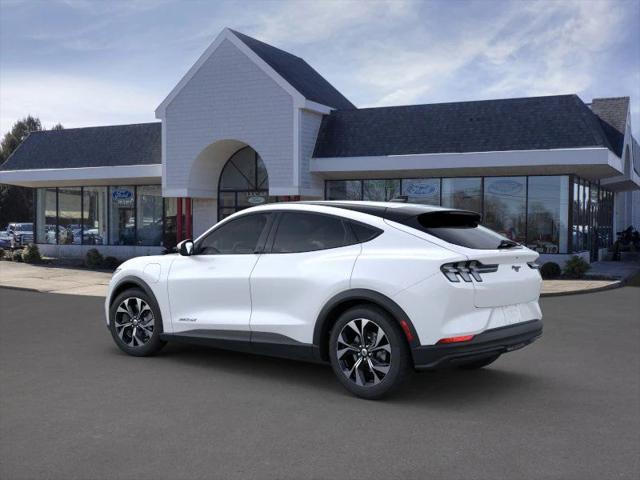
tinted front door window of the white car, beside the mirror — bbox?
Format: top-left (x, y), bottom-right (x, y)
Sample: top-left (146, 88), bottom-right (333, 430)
top-left (196, 212), bottom-right (270, 255)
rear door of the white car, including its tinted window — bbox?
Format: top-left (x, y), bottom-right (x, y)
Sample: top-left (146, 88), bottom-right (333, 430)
top-left (251, 211), bottom-right (361, 343)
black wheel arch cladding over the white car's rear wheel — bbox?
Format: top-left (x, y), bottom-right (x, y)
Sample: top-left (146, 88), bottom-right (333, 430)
top-left (313, 289), bottom-right (420, 361)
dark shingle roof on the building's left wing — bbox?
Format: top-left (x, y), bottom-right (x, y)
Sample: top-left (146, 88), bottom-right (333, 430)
top-left (0, 122), bottom-right (162, 170)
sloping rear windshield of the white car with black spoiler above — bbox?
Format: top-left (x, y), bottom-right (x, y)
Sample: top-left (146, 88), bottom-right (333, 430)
top-left (411, 211), bottom-right (519, 250)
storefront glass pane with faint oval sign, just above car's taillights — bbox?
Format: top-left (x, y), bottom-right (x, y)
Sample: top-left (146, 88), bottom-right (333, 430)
top-left (482, 177), bottom-right (527, 243)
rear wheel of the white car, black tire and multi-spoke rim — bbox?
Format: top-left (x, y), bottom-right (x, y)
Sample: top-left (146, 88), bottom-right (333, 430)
top-left (329, 305), bottom-right (413, 400)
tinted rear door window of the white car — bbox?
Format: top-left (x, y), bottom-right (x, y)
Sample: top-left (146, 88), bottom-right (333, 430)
top-left (271, 212), bottom-right (356, 253)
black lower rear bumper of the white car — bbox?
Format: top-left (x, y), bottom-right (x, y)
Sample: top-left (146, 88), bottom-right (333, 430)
top-left (412, 320), bottom-right (542, 370)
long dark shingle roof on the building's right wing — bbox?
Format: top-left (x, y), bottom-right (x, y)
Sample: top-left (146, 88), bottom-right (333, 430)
top-left (314, 95), bottom-right (611, 157)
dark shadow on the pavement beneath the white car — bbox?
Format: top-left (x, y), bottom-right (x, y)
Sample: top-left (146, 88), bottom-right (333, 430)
top-left (136, 344), bottom-right (545, 410)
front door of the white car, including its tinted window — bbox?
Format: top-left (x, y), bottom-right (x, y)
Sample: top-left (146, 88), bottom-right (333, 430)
top-left (167, 212), bottom-right (271, 334)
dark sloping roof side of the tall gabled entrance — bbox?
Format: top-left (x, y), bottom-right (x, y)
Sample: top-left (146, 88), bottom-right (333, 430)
top-left (231, 30), bottom-right (356, 109)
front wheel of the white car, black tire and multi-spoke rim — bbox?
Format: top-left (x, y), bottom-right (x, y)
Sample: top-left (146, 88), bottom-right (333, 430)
top-left (109, 288), bottom-right (166, 357)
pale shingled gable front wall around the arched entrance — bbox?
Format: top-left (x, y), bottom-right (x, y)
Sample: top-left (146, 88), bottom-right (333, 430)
top-left (163, 39), bottom-right (296, 198)
